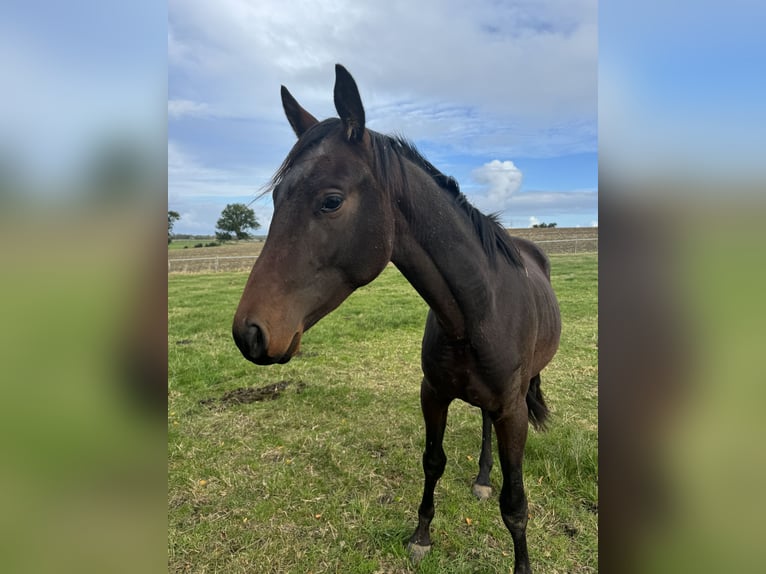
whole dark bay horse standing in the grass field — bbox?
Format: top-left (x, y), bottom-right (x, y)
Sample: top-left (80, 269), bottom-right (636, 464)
top-left (232, 65), bottom-right (561, 574)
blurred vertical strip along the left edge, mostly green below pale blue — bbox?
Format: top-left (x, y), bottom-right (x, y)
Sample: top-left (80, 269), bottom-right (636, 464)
top-left (0, 0), bottom-right (167, 573)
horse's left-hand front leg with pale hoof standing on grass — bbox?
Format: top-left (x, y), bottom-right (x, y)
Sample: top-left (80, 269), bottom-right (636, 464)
top-left (407, 378), bottom-right (450, 563)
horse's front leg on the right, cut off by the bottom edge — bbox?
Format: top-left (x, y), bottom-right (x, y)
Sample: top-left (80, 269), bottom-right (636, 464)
top-left (494, 397), bottom-right (532, 574)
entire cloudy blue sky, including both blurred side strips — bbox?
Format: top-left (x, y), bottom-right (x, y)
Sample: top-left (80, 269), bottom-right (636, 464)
top-left (0, 0), bottom-right (766, 233)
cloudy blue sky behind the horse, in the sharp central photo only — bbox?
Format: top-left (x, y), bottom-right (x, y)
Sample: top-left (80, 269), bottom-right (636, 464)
top-left (167, 0), bottom-right (598, 234)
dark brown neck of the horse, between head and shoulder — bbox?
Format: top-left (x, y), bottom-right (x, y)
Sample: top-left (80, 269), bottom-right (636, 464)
top-left (391, 172), bottom-right (500, 339)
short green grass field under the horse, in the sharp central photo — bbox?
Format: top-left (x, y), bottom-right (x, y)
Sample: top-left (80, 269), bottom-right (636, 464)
top-left (168, 254), bottom-right (598, 574)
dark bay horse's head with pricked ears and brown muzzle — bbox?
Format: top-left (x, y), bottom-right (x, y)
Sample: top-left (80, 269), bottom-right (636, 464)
top-left (232, 65), bottom-right (394, 365)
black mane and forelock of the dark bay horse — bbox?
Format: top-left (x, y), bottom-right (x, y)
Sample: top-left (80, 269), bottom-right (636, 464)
top-left (270, 118), bottom-right (524, 268)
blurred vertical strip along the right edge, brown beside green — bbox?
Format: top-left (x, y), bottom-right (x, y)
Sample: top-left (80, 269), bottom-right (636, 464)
top-left (599, 0), bottom-right (766, 573)
